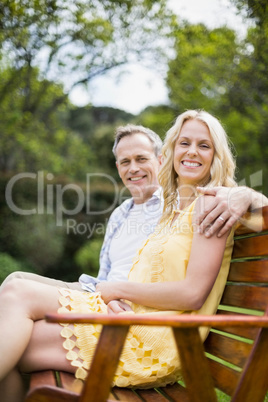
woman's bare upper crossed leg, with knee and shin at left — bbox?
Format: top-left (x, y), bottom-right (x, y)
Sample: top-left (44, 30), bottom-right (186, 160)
top-left (0, 279), bottom-right (64, 381)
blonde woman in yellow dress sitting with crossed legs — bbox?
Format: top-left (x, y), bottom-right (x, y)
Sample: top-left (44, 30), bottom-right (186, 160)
top-left (0, 111), bottom-right (235, 402)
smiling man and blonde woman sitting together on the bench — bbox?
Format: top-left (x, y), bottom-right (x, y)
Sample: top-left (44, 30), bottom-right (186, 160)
top-left (0, 110), bottom-right (268, 402)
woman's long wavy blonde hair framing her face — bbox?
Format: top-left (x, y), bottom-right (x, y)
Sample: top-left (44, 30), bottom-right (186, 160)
top-left (159, 110), bottom-right (236, 220)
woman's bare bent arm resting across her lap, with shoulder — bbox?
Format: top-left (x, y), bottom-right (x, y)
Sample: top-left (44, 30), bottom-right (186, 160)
top-left (97, 196), bottom-right (228, 310)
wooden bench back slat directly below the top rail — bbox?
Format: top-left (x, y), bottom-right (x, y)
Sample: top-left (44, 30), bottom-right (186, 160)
top-left (232, 234), bottom-right (268, 258)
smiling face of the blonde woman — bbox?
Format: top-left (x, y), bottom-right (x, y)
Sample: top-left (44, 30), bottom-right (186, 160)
top-left (173, 119), bottom-right (215, 186)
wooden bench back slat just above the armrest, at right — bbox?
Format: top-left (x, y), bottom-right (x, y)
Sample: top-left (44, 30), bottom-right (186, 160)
top-left (221, 284), bottom-right (268, 311)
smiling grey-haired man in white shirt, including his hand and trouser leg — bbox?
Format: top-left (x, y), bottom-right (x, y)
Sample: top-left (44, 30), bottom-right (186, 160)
top-left (2, 124), bottom-right (268, 291)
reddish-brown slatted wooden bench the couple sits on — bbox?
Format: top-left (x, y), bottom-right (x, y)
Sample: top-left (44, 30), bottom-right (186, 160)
top-left (26, 207), bottom-right (268, 402)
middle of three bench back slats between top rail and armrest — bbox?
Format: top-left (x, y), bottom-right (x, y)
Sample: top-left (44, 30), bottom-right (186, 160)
top-left (228, 260), bottom-right (268, 283)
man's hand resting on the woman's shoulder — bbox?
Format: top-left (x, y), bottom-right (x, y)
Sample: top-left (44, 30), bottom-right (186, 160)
top-left (195, 187), bottom-right (253, 237)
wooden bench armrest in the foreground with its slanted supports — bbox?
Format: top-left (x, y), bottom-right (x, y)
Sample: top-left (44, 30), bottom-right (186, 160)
top-left (46, 313), bottom-right (268, 402)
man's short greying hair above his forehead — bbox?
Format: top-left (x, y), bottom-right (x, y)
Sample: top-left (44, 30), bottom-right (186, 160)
top-left (113, 124), bottom-right (163, 157)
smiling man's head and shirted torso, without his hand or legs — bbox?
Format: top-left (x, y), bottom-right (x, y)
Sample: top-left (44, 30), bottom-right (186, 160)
top-left (79, 125), bottom-right (163, 290)
